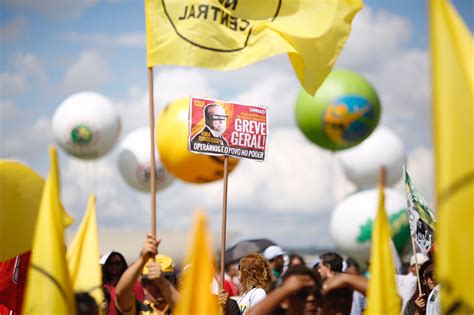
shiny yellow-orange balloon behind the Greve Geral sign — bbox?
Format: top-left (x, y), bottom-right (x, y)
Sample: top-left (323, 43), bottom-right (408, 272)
top-left (155, 97), bottom-right (239, 184)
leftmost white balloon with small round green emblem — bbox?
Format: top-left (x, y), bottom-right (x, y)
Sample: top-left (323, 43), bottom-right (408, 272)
top-left (52, 92), bottom-right (121, 160)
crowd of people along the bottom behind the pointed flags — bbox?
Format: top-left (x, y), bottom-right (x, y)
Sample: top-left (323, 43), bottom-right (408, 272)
top-left (78, 235), bottom-right (440, 315)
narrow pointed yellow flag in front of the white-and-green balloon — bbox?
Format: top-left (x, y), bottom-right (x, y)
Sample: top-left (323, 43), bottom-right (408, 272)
top-left (364, 185), bottom-right (401, 315)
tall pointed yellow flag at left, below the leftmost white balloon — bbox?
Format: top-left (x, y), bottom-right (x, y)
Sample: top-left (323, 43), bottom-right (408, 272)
top-left (23, 147), bottom-right (75, 314)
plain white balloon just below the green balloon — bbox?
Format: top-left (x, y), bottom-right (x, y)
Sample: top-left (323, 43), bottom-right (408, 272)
top-left (337, 126), bottom-right (406, 189)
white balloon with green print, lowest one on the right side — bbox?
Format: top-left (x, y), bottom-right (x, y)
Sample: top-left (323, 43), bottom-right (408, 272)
top-left (329, 188), bottom-right (410, 266)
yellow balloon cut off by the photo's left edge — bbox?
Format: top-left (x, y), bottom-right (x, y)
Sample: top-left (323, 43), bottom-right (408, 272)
top-left (0, 160), bottom-right (44, 261)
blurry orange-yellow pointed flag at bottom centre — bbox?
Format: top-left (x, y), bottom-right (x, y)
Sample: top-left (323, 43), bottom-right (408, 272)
top-left (173, 212), bottom-right (219, 315)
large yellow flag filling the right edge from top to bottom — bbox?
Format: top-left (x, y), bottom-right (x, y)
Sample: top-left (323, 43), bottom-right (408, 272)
top-left (430, 0), bottom-right (474, 314)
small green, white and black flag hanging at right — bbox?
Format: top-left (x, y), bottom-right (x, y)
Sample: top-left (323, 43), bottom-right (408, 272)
top-left (403, 165), bottom-right (436, 255)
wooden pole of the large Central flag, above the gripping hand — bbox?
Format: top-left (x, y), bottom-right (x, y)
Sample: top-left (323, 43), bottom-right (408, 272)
top-left (148, 67), bottom-right (156, 236)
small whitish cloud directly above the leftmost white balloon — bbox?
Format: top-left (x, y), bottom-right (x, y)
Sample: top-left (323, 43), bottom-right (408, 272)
top-left (62, 50), bottom-right (110, 93)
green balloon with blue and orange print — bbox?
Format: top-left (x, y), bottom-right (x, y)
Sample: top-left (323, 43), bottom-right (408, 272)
top-left (295, 70), bottom-right (380, 151)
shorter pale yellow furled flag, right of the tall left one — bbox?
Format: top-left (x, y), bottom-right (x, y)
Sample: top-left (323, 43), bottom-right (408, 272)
top-left (67, 194), bottom-right (104, 305)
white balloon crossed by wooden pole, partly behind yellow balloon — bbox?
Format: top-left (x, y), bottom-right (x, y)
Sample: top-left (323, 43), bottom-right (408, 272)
top-left (118, 127), bottom-right (174, 192)
